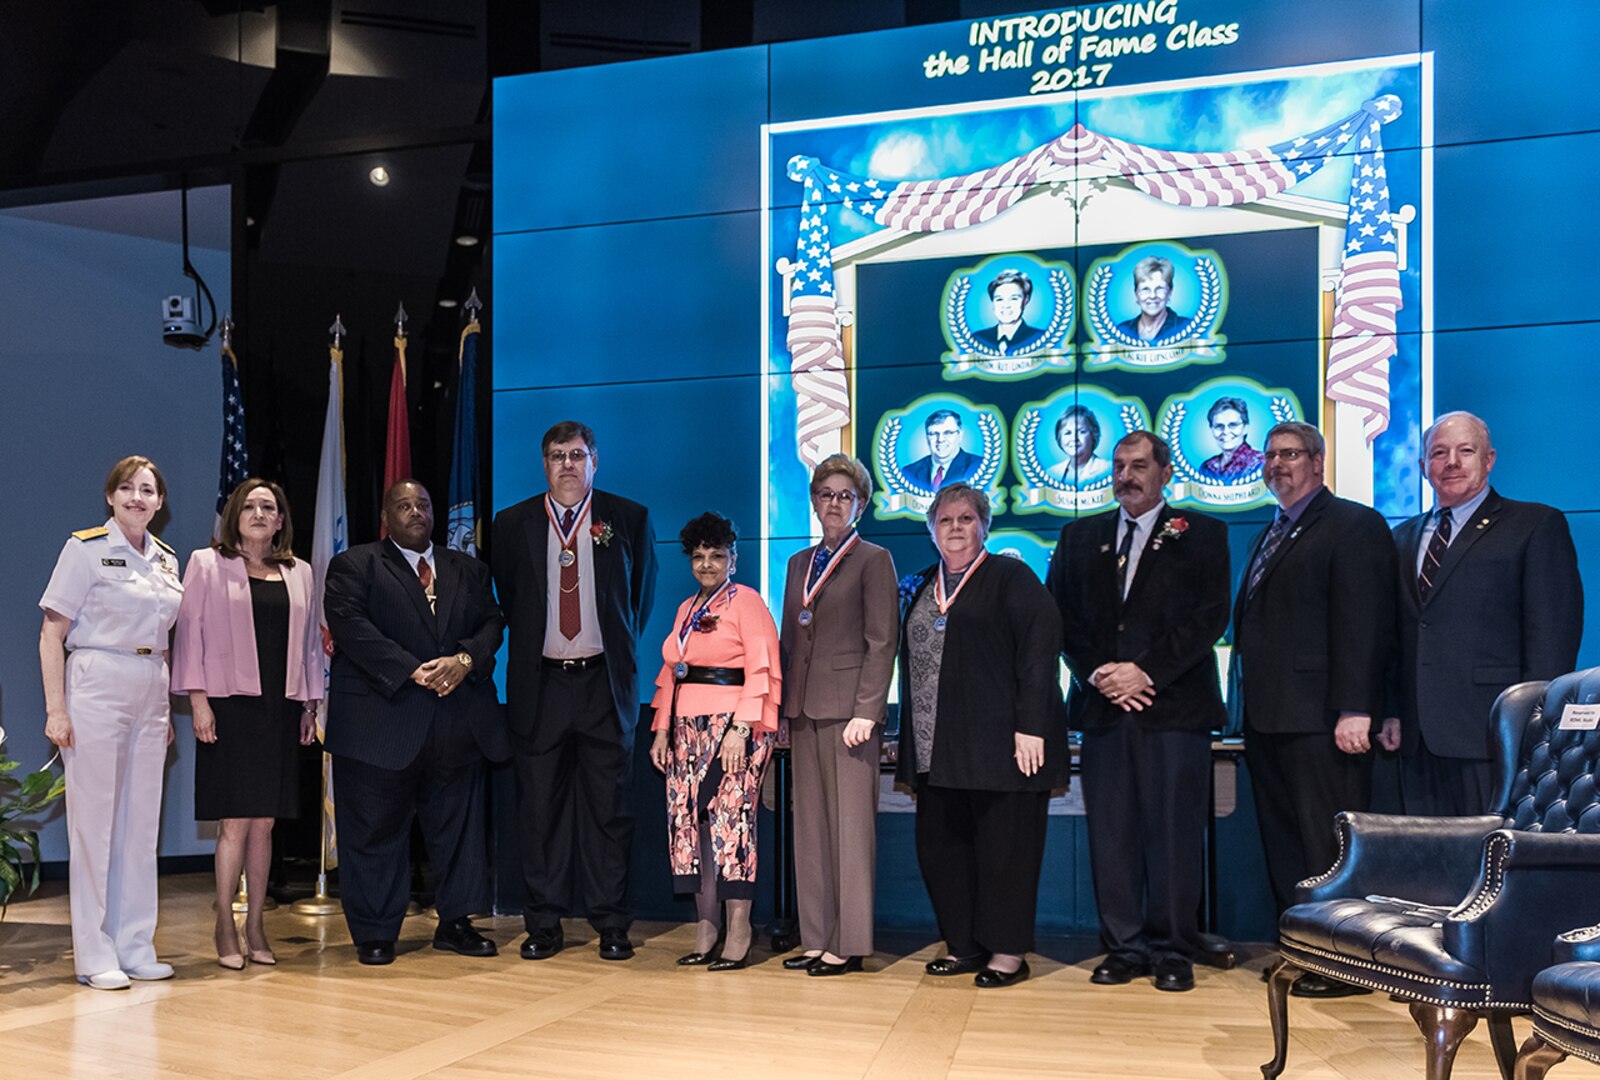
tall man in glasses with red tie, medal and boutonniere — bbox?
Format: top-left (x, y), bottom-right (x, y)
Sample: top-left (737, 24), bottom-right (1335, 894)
top-left (493, 421), bottom-right (656, 960)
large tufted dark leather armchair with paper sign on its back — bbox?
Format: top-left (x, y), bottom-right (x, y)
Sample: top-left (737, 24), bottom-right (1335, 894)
top-left (1261, 667), bottom-right (1600, 1080)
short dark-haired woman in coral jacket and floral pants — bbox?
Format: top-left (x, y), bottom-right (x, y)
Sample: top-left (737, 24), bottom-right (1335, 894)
top-left (650, 512), bottom-right (782, 971)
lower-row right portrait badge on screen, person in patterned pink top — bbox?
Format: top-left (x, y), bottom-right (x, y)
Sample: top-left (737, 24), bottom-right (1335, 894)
top-left (1155, 376), bottom-right (1304, 510)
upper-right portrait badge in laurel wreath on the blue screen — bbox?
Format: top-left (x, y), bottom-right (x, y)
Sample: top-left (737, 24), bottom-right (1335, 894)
top-left (1083, 240), bottom-right (1227, 371)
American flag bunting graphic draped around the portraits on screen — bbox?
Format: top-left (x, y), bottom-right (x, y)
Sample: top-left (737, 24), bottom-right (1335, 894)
top-left (787, 94), bottom-right (1400, 466)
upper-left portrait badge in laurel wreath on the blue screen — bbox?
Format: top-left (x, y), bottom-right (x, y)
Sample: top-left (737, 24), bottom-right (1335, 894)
top-left (939, 253), bottom-right (1077, 379)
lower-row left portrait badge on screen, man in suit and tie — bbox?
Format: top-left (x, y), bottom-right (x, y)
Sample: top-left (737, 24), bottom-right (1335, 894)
top-left (872, 394), bottom-right (1006, 520)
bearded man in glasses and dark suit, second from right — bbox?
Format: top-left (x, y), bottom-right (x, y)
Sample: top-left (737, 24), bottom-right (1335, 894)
top-left (1229, 422), bottom-right (1400, 997)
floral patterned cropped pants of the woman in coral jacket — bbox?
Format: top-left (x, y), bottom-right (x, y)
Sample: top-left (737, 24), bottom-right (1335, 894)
top-left (667, 712), bottom-right (773, 899)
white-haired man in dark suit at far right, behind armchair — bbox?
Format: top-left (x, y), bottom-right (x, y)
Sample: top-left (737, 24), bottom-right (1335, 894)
top-left (1395, 413), bottom-right (1584, 814)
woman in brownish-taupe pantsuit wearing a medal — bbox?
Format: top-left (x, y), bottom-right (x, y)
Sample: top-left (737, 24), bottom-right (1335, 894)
top-left (782, 454), bottom-right (899, 976)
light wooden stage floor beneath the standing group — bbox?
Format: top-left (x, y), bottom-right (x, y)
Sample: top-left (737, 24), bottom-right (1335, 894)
top-left (0, 875), bottom-right (1516, 1080)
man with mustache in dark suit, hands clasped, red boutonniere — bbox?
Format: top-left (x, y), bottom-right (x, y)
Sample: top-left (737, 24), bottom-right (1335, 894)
top-left (1046, 430), bottom-right (1230, 990)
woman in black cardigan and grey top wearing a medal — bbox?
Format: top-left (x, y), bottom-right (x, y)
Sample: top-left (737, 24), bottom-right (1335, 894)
top-left (896, 483), bottom-right (1070, 987)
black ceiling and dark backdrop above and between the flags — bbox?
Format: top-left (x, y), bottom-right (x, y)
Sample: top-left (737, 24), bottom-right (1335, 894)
top-left (0, 0), bottom-right (992, 534)
